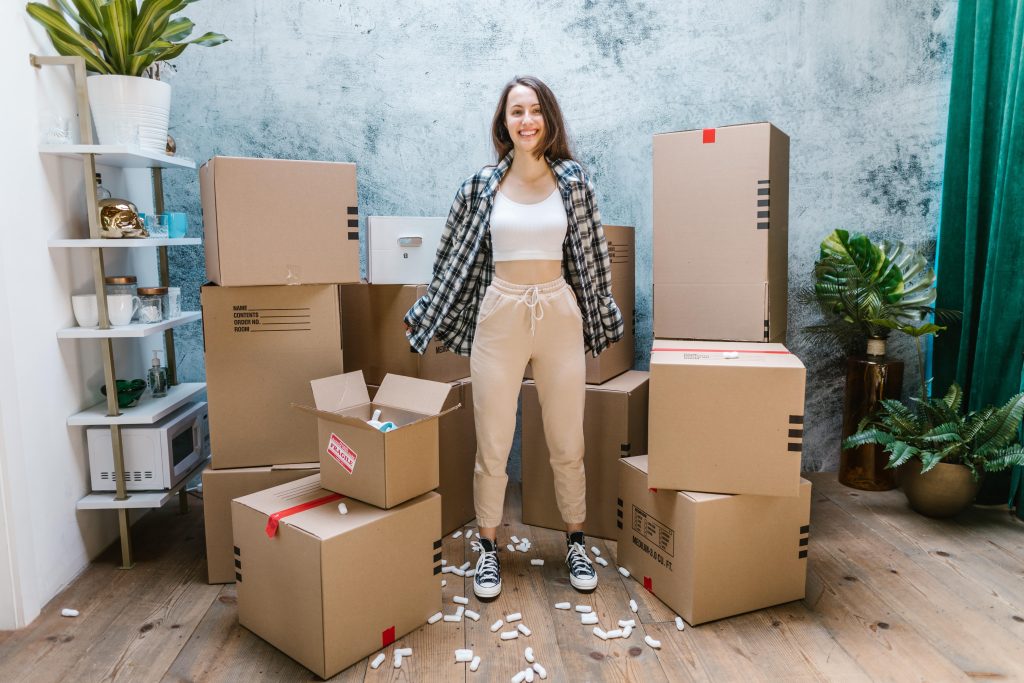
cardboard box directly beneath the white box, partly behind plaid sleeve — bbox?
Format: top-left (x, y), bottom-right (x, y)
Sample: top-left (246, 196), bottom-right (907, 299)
top-left (340, 285), bottom-right (469, 384)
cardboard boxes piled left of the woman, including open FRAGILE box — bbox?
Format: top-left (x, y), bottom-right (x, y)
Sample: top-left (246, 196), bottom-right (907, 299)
top-left (201, 157), bottom-right (454, 678)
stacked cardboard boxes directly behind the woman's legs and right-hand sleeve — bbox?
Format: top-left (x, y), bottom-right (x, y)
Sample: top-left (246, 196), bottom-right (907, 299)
top-left (521, 225), bottom-right (648, 539)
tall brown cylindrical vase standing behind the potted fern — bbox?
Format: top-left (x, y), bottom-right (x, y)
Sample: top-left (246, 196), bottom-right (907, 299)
top-left (839, 340), bottom-right (903, 490)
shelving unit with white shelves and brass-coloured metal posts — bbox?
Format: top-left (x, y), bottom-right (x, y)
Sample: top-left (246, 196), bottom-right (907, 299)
top-left (30, 54), bottom-right (203, 569)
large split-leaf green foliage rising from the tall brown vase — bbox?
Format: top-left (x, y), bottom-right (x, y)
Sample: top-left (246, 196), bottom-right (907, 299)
top-left (801, 229), bottom-right (955, 358)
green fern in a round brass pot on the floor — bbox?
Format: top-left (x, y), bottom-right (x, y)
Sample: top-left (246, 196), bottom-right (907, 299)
top-left (843, 383), bottom-right (1024, 517)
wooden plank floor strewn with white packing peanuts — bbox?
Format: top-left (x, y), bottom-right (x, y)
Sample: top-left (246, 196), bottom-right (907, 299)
top-left (0, 473), bottom-right (1024, 683)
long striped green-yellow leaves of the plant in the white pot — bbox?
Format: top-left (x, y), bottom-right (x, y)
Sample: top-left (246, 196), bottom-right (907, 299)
top-left (26, 0), bottom-right (228, 76)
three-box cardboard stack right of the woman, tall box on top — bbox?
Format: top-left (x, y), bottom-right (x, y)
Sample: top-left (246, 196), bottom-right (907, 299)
top-left (616, 123), bottom-right (811, 624)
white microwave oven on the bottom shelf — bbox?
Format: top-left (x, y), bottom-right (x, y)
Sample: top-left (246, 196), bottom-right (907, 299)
top-left (86, 401), bottom-right (210, 490)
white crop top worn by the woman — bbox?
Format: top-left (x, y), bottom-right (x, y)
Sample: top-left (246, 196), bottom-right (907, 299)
top-left (490, 187), bottom-right (568, 261)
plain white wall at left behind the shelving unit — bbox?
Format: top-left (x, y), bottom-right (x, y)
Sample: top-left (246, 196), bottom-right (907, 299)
top-left (0, 2), bottom-right (156, 629)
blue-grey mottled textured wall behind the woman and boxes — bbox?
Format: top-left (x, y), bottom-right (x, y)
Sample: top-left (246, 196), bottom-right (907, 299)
top-left (165, 0), bottom-right (956, 469)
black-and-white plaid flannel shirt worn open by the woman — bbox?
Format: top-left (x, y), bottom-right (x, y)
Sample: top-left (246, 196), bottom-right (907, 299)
top-left (406, 152), bottom-right (624, 355)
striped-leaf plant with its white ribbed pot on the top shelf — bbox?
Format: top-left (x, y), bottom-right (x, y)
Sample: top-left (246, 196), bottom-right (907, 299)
top-left (26, 0), bottom-right (227, 153)
